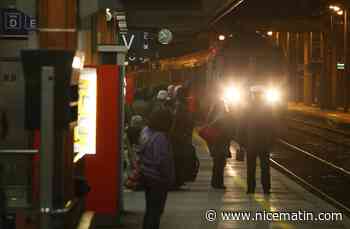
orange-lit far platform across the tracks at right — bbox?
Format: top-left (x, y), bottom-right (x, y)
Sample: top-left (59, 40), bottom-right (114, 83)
top-left (288, 103), bottom-right (350, 126)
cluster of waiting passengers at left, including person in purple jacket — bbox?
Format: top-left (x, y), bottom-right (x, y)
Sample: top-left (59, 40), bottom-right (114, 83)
top-left (126, 85), bottom-right (199, 229)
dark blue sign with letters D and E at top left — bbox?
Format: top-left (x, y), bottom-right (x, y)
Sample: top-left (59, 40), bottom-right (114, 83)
top-left (0, 9), bottom-right (37, 38)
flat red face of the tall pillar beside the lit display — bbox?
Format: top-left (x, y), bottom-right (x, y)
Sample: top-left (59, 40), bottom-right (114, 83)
top-left (85, 65), bottom-right (122, 214)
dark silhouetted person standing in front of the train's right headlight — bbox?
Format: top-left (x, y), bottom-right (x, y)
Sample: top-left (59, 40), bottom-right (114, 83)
top-left (245, 87), bottom-right (277, 195)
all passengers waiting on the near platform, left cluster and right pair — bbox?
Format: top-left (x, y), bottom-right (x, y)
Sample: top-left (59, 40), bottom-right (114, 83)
top-left (126, 82), bottom-right (282, 229)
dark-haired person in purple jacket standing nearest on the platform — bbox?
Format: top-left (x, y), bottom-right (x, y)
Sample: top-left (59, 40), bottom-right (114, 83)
top-left (139, 109), bottom-right (175, 229)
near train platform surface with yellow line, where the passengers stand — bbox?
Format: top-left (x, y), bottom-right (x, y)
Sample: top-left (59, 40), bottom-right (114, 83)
top-left (85, 132), bottom-right (350, 229)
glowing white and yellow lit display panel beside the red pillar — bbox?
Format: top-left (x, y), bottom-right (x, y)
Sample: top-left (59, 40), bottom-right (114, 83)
top-left (74, 68), bottom-right (97, 156)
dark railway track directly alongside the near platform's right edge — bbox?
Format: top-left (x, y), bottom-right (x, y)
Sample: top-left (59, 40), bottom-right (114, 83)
top-left (270, 139), bottom-right (350, 216)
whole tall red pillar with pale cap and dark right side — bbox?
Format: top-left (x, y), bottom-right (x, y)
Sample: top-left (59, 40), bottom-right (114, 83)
top-left (86, 45), bottom-right (127, 218)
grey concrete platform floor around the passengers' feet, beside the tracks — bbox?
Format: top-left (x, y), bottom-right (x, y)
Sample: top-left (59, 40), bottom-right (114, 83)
top-left (125, 151), bottom-right (350, 229)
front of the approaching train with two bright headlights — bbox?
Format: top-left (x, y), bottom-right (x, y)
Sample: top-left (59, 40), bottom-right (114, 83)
top-left (208, 32), bottom-right (288, 107)
